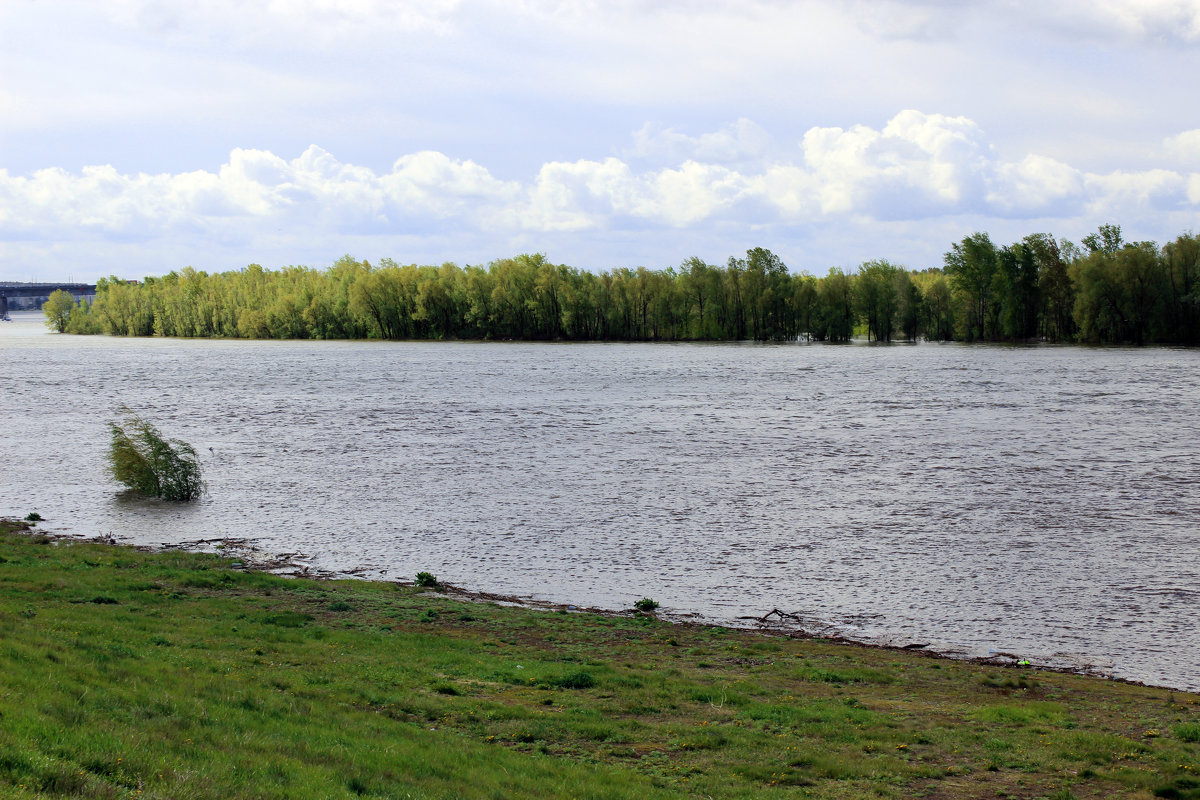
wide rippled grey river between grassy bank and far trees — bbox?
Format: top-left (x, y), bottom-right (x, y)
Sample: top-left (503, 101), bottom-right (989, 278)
top-left (0, 313), bottom-right (1200, 691)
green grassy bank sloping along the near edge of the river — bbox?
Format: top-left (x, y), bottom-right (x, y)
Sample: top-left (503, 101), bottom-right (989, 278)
top-left (0, 522), bottom-right (1200, 800)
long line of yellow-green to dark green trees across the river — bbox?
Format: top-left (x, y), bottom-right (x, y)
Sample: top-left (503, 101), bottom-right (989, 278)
top-left (54, 225), bottom-right (1200, 344)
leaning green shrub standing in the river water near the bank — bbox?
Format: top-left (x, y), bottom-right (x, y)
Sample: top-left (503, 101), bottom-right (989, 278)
top-left (108, 408), bottom-right (204, 500)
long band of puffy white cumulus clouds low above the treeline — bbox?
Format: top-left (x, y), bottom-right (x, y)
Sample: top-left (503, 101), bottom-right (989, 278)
top-left (7, 110), bottom-right (1200, 280)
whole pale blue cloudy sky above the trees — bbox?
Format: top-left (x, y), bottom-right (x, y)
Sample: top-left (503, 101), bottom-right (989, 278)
top-left (0, 0), bottom-right (1200, 282)
